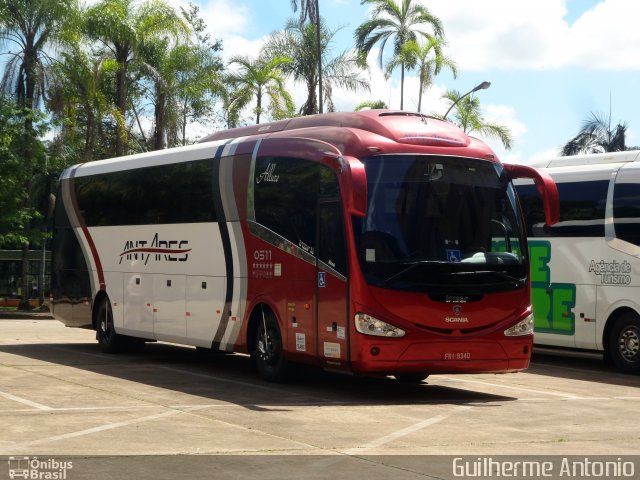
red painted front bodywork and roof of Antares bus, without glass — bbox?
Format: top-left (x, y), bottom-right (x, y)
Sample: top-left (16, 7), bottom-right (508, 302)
top-left (215, 111), bottom-right (533, 374)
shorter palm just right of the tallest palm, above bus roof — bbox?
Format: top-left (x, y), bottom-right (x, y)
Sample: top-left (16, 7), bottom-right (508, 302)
top-left (385, 37), bottom-right (458, 112)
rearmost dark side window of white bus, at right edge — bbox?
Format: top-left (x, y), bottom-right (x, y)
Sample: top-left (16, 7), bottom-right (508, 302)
top-left (613, 166), bottom-right (640, 246)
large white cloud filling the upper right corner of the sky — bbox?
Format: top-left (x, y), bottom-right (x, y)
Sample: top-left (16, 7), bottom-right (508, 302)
top-left (422, 0), bottom-right (640, 71)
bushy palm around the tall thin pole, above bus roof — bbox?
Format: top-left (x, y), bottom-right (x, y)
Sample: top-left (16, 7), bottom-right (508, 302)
top-left (263, 20), bottom-right (369, 115)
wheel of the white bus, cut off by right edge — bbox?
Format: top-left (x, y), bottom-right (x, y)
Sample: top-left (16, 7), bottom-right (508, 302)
top-left (609, 313), bottom-right (640, 373)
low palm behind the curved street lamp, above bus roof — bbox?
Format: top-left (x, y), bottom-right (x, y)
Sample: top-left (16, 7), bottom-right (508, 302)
top-left (433, 90), bottom-right (513, 150)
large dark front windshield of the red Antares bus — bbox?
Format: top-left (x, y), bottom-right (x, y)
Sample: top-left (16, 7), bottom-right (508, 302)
top-left (353, 155), bottom-right (528, 293)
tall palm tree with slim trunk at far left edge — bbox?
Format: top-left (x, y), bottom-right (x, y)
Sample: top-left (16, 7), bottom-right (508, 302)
top-left (0, 0), bottom-right (77, 308)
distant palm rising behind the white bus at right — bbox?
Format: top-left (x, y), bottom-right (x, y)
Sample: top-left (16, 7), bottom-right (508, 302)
top-left (561, 112), bottom-right (635, 155)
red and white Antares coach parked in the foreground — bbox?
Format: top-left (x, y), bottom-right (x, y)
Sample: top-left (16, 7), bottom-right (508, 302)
top-left (52, 110), bottom-right (558, 381)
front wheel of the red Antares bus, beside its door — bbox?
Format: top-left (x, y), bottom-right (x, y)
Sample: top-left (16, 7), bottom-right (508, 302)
top-left (253, 310), bottom-right (288, 382)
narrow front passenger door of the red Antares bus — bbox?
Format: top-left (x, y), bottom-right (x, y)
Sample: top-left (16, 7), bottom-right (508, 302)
top-left (316, 198), bottom-right (349, 370)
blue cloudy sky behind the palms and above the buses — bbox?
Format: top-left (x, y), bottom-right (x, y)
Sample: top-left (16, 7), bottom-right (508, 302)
top-left (179, 0), bottom-right (640, 163)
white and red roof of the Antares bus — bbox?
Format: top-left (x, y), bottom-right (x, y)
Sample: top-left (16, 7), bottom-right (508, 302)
top-left (63, 110), bottom-right (498, 178)
